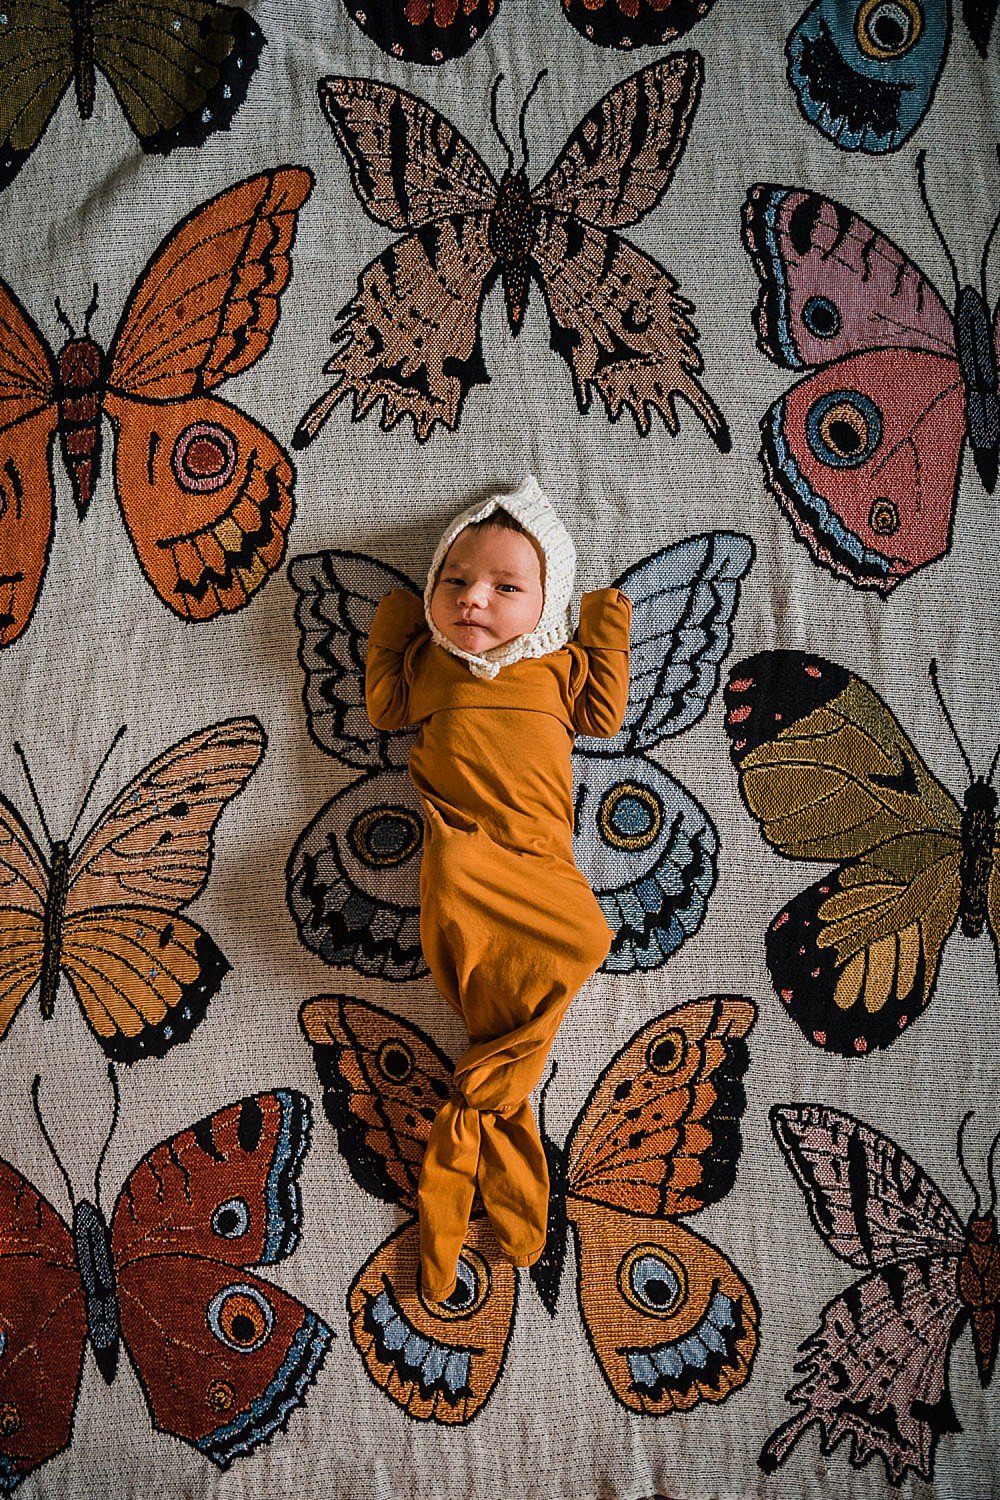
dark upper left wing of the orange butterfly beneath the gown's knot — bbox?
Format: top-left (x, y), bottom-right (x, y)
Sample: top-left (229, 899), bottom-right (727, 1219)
top-left (300, 995), bottom-right (453, 1211)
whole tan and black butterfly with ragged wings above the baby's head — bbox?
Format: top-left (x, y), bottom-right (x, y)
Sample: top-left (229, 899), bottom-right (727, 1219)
top-left (292, 53), bottom-right (730, 453)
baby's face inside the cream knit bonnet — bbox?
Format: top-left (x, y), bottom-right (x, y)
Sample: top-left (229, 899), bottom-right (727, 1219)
top-left (430, 527), bottom-right (544, 656)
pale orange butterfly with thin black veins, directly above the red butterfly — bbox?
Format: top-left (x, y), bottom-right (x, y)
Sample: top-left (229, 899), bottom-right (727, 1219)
top-left (0, 719), bottom-right (267, 1062)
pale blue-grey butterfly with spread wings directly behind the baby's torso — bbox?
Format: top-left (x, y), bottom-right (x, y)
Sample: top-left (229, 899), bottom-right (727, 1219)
top-left (288, 531), bottom-right (754, 981)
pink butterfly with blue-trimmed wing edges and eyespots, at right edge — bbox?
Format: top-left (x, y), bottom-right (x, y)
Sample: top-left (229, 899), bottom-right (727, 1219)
top-left (744, 153), bottom-right (1000, 594)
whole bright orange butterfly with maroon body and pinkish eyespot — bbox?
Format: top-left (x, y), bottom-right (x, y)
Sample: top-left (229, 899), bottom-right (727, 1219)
top-left (0, 167), bottom-right (313, 647)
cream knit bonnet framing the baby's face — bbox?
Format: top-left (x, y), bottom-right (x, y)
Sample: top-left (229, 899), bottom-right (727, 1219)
top-left (424, 474), bottom-right (576, 678)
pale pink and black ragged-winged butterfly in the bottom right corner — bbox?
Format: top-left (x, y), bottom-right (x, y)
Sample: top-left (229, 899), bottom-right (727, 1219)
top-left (759, 1104), bottom-right (1000, 1485)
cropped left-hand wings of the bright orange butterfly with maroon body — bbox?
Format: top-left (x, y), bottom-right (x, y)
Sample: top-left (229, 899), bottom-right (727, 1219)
top-left (0, 279), bottom-right (58, 648)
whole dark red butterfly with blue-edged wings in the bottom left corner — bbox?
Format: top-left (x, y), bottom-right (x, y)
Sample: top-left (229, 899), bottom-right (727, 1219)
top-left (0, 1074), bottom-right (333, 1494)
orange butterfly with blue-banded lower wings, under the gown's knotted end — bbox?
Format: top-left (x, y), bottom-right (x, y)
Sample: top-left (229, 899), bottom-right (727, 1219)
top-left (300, 995), bottom-right (759, 1425)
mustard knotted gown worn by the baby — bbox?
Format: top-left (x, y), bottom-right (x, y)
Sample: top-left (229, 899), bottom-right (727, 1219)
top-left (366, 588), bottom-right (631, 1302)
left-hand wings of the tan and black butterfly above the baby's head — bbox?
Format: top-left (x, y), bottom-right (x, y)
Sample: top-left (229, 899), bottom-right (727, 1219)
top-left (292, 78), bottom-right (498, 447)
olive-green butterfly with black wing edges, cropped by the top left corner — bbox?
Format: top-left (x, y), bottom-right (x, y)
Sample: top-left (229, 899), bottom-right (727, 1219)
top-left (0, 0), bottom-right (264, 188)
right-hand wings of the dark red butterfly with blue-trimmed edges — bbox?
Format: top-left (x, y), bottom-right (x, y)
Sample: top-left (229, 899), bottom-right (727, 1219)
top-left (111, 1089), bottom-right (333, 1469)
